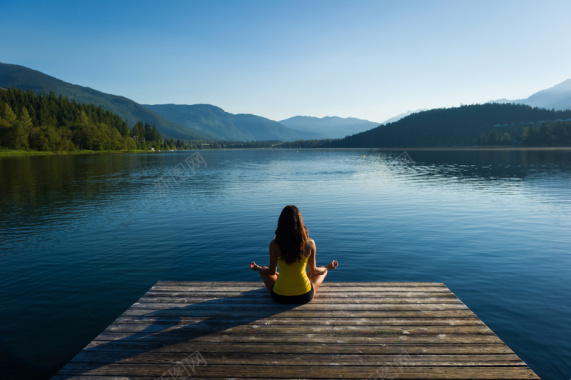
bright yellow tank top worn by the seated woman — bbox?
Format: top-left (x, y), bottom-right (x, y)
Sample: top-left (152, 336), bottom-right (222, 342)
top-left (273, 255), bottom-right (311, 296)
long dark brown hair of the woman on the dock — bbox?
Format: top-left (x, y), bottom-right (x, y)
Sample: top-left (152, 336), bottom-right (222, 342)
top-left (275, 205), bottom-right (309, 264)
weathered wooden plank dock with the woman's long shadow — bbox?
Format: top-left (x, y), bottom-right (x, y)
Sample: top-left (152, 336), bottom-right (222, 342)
top-left (54, 281), bottom-right (539, 380)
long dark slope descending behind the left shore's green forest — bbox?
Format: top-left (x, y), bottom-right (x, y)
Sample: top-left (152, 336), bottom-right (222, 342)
top-left (0, 63), bottom-right (209, 139)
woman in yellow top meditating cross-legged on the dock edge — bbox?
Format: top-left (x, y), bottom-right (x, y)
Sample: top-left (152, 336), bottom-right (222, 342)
top-left (250, 206), bottom-right (338, 304)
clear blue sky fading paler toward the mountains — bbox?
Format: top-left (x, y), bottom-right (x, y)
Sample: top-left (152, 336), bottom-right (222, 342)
top-left (0, 0), bottom-right (571, 122)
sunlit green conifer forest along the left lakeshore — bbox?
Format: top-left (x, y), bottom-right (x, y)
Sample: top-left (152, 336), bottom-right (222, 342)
top-left (0, 88), bottom-right (165, 152)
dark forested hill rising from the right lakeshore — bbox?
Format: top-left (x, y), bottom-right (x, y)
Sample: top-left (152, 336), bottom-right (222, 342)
top-left (328, 104), bottom-right (571, 148)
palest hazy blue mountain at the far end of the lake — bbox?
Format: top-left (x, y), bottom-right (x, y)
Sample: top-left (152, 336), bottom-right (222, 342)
top-left (280, 116), bottom-right (379, 139)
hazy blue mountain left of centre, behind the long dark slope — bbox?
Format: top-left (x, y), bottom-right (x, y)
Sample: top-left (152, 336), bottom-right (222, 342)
top-left (145, 104), bottom-right (310, 141)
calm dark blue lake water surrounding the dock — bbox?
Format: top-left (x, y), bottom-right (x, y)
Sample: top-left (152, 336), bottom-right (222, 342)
top-left (0, 150), bottom-right (571, 379)
